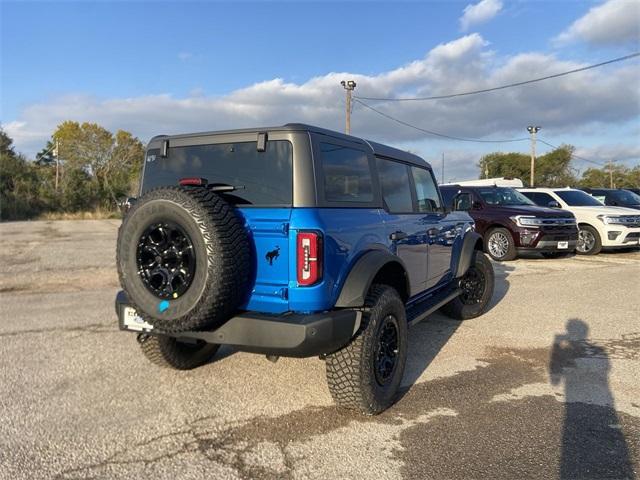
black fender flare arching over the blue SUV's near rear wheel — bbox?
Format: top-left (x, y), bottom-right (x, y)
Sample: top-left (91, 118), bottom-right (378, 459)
top-left (335, 250), bottom-right (411, 308)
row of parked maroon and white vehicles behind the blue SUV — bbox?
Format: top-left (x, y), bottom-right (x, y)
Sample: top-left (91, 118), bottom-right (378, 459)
top-left (441, 182), bottom-right (640, 261)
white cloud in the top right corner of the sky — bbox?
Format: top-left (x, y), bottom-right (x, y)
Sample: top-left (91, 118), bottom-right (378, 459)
top-left (555, 0), bottom-right (640, 46)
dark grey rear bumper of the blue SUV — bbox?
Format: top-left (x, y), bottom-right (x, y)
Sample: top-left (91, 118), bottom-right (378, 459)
top-left (116, 292), bottom-right (362, 357)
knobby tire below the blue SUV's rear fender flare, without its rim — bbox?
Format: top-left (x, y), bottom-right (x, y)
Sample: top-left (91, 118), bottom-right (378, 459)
top-left (326, 284), bottom-right (407, 415)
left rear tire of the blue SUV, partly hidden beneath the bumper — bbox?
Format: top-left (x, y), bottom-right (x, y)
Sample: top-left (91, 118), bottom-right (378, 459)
top-left (138, 334), bottom-right (220, 370)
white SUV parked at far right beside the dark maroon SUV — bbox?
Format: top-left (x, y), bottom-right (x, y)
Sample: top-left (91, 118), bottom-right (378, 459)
top-left (518, 188), bottom-right (640, 255)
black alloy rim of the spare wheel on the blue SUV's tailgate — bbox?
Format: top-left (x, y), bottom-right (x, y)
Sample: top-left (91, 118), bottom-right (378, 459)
top-left (136, 222), bottom-right (196, 299)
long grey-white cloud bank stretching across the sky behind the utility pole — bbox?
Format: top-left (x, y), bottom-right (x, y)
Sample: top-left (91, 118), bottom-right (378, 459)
top-left (4, 34), bottom-right (640, 167)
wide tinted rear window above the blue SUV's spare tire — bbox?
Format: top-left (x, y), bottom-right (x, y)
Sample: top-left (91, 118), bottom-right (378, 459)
top-left (142, 140), bottom-right (293, 206)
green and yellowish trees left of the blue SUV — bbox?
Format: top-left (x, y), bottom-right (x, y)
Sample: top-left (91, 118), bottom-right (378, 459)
top-left (0, 121), bottom-right (144, 220)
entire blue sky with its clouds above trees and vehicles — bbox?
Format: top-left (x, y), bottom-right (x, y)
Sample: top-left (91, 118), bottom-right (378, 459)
top-left (0, 0), bottom-right (640, 179)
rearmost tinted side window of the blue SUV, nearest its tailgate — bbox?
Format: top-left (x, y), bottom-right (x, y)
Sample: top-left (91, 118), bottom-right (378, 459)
top-left (320, 143), bottom-right (373, 203)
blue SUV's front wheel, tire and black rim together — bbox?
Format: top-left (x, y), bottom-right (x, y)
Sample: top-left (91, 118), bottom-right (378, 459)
top-left (441, 250), bottom-right (495, 320)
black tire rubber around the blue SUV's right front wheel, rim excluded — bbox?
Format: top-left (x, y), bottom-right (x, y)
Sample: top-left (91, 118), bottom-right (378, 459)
top-left (440, 250), bottom-right (495, 320)
